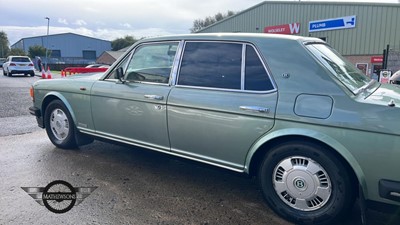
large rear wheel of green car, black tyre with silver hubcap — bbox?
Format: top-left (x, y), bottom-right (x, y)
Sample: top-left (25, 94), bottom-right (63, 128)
top-left (259, 142), bottom-right (355, 224)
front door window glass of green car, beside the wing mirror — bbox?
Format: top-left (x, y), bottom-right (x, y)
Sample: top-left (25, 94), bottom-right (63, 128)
top-left (125, 42), bottom-right (178, 84)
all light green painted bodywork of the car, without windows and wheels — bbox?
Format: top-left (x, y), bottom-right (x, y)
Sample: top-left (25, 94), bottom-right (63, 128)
top-left (34, 34), bottom-right (400, 204)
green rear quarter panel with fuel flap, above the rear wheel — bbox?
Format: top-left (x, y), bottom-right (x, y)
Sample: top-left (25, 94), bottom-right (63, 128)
top-left (248, 39), bottom-right (400, 204)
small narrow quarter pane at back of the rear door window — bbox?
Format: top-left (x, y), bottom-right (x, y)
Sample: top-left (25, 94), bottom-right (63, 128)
top-left (244, 45), bottom-right (274, 91)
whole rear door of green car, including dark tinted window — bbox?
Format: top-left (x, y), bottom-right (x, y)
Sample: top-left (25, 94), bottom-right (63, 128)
top-left (167, 41), bottom-right (277, 170)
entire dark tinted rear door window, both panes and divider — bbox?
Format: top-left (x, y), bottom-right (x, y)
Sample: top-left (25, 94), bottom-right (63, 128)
top-left (177, 41), bottom-right (274, 92)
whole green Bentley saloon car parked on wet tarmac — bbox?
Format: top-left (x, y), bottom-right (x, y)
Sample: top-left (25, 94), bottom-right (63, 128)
top-left (30, 33), bottom-right (400, 224)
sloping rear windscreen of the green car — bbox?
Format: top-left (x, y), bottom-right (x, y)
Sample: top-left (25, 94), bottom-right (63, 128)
top-left (306, 43), bottom-right (371, 94)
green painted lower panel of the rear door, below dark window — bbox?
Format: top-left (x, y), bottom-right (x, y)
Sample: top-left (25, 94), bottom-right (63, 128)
top-left (168, 87), bottom-right (278, 170)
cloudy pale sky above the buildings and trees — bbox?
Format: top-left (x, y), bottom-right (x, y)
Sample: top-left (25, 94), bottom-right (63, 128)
top-left (0, 0), bottom-right (399, 44)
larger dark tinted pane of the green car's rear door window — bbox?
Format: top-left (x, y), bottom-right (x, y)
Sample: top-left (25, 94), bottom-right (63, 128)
top-left (178, 42), bottom-right (242, 90)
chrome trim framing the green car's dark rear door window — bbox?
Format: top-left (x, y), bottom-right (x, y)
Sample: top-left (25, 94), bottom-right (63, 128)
top-left (177, 40), bottom-right (277, 94)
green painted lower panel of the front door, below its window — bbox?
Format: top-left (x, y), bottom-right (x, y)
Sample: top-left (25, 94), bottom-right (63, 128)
top-left (91, 81), bottom-right (170, 150)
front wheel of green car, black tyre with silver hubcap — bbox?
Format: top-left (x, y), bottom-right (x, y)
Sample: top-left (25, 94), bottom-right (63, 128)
top-left (44, 100), bottom-right (77, 149)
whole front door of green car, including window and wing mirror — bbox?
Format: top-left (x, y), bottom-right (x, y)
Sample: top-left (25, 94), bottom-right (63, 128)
top-left (91, 42), bottom-right (178, 151)
